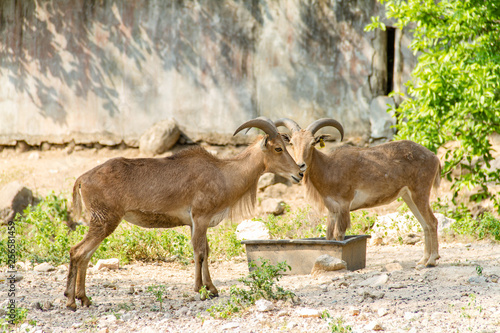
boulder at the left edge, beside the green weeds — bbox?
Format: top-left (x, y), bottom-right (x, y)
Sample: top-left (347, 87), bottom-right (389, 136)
top-left (0, 181), bottom-right (33, 223)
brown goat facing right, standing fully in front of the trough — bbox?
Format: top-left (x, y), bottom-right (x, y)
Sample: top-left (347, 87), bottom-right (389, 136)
top-left (64, 118), bottom-right (302, 310)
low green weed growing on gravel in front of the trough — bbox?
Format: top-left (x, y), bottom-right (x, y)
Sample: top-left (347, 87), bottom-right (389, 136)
top-left (207, 259), bottom-right (295, 319)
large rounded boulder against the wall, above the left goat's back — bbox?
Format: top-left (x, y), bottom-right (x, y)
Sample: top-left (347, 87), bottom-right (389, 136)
top-left (139, 118), bottom-right (181, 155)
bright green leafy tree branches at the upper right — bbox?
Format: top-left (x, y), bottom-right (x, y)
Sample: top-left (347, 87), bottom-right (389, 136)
top-left (366, 0), bottom-right (500, 212)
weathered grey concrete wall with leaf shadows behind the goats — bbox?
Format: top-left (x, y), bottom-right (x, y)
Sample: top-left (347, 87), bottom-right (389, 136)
top-left (0, 0), bottom-right (412, 146)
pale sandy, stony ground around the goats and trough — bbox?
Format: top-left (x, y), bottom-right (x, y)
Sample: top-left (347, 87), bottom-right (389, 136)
top-left (0, 142), bottom-right (500, 332)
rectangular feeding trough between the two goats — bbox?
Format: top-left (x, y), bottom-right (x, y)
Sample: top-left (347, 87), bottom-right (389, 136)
top-left (241, 235), bottom-right (370, 274)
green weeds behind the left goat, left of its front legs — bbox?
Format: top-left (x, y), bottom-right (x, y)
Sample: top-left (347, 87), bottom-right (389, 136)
top-left (0, 194), bottom-right (192, 265)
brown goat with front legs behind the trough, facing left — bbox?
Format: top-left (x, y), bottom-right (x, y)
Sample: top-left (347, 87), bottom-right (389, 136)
top-left (275, 118), bottom-right (441, 266)
